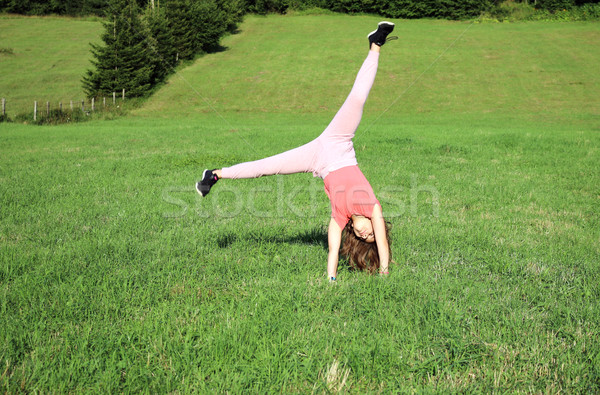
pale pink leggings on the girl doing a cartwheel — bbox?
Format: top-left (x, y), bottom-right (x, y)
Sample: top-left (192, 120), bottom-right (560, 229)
top-left (221, 51), bottom-right (379, 179)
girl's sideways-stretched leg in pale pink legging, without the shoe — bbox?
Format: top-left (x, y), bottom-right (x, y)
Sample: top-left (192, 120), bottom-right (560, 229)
top-left (219, 140), bottom-right (321, 179)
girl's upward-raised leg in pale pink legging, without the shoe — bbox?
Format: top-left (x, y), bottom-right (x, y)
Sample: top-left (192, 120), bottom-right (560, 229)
top-left (321, 46), bottom-right (379, 141)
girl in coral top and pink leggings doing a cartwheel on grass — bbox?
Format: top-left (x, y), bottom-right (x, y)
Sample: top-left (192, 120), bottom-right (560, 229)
top-left (196, 22), bottom-right (397, 281)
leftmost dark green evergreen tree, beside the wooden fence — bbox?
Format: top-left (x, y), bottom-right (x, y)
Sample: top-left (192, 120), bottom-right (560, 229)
top-left (83, 0), bottom-right (153, 97)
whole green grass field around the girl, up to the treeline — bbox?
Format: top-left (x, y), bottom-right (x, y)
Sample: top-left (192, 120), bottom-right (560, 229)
top-left (0, 15), bottom-right (600, 393)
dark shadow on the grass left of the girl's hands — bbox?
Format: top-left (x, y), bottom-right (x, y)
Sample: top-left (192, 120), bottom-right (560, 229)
top-left (217, 228), bottom-right (327, 248)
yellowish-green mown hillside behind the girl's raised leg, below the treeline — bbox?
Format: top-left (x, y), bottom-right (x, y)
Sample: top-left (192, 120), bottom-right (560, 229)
top-left (139, 15), bottom-right (600, 123)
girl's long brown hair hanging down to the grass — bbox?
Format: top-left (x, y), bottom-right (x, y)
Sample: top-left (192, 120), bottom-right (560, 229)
top-left (340, 219), bottom-right (392, 274)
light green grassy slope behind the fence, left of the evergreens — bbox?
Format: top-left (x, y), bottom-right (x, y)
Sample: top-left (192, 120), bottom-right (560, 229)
top-left (0, 16), bottom-right (102, 117)
